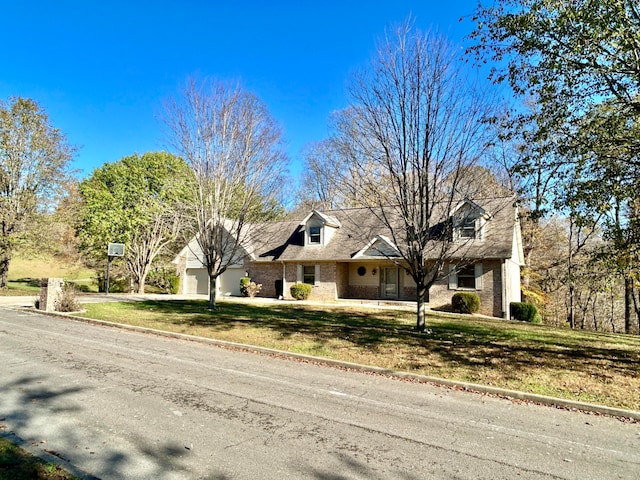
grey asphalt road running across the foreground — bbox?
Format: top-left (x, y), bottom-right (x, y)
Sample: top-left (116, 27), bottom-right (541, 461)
top-left (0, 307), bottom-right (640, 480)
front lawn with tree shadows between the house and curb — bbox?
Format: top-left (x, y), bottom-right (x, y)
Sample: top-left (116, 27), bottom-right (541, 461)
top-left (83, 299), bottom-right (640, 411)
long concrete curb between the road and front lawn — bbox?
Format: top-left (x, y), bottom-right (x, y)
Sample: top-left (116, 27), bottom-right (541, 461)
top-left (23, 310), bottom-right (640, 422)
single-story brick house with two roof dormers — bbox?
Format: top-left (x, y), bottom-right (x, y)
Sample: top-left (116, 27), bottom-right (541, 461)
top-left (175, 197), bottom-right (523, 317)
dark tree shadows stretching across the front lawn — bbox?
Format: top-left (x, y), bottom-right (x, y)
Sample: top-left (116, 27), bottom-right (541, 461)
top-left (109, 300), bottom-right (640, 382)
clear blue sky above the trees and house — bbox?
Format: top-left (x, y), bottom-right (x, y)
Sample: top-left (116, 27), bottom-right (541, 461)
top-left (0, 0), bottom-right (476, 180)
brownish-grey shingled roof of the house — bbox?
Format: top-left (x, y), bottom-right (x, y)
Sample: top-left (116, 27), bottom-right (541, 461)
top-left (249, 197), bottom-right (517, 262)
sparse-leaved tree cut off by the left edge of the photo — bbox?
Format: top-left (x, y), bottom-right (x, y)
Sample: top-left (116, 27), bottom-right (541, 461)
top-left (0, 97), bottom-right (75, 288)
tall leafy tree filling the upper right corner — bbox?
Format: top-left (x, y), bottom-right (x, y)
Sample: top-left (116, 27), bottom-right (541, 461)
top-left (470, 0), bottom-right (640, 331)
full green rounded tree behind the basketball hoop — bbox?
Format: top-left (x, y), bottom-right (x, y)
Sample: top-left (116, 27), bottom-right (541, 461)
top-left (77, 152), bottom-right (191, 293)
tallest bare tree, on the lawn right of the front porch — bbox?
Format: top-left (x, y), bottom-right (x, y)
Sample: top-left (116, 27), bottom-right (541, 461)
top-left (334, 21), bottom-right (494, 331)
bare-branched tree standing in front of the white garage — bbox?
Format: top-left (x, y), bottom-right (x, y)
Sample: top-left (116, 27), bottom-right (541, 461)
top-left (164, 79), bottom-right (287, 309)
